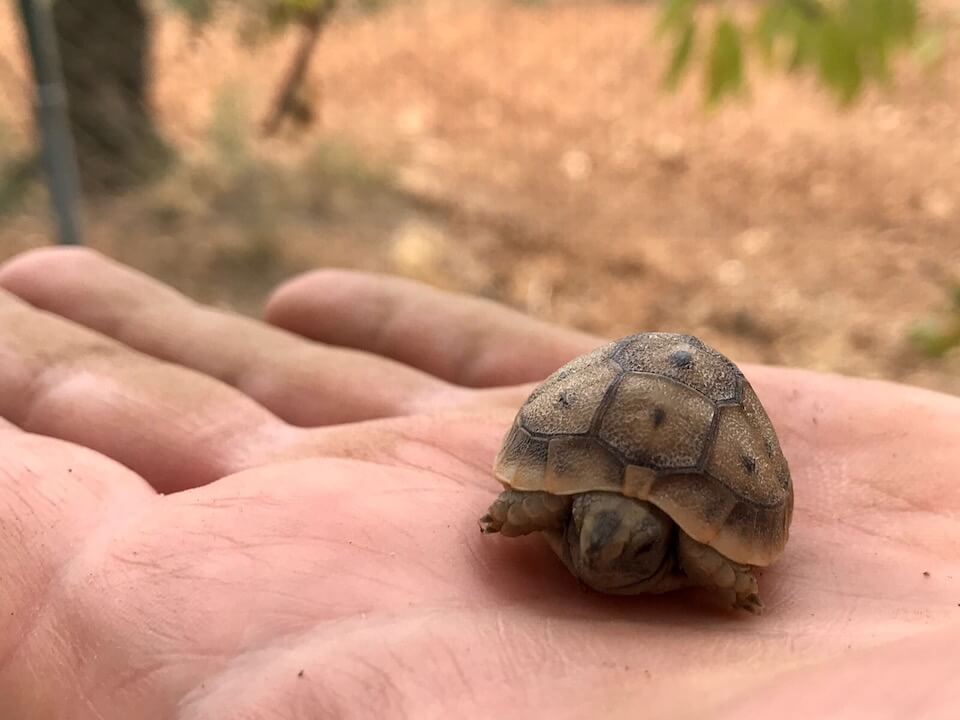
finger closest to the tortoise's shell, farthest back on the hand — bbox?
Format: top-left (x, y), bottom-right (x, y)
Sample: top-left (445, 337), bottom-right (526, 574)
top-left (265, 270), bottom-right (604, 387)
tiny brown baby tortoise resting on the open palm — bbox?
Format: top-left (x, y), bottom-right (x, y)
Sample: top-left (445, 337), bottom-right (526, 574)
top-left (480, 333), bottom-right (793, 613)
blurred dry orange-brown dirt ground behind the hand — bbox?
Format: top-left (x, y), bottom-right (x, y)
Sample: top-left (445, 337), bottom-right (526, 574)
top-left (0, 0), bottom-right (960, 393)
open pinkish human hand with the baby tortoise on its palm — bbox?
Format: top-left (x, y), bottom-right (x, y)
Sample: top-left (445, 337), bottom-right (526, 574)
top-left (0, 250), bottom-right (960, 720)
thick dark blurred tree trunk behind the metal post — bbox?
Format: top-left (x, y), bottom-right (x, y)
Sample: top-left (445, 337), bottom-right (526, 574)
top-left (53, 0), bottom-right (171, 195)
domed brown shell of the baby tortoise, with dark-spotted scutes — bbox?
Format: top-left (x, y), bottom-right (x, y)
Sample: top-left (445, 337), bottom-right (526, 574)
top-left (494, 333), bottom-right (793, 566)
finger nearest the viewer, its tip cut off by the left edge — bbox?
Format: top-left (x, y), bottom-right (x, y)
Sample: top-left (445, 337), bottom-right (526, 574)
top-left (0, 292), bottom-right (294, 492)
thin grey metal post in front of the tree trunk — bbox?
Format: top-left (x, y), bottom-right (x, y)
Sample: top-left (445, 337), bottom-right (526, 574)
top-left (19, 0), bottom-right (80, 245)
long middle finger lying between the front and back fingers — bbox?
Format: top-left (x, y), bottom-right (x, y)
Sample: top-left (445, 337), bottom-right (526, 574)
top-left (0, 248), bottom-right (457, 425)
